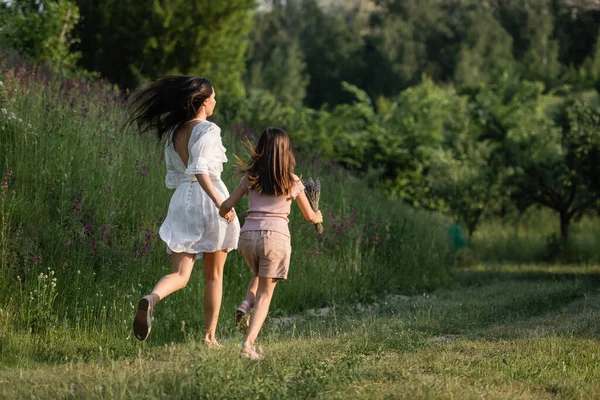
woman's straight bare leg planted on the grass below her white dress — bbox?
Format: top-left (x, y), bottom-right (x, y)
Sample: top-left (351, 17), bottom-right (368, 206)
top-left (204, 250), bottom-right (227, 344)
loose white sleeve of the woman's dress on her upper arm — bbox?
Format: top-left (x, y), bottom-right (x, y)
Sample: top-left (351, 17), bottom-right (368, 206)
top-left (185, 124), bottom-right (222, 175)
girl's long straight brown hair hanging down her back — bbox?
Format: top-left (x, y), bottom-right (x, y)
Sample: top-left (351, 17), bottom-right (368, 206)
top-left (238, 128), bottom-right (296, 196)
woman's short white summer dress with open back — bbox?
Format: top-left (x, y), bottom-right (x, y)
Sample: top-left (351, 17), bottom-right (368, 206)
top-left (159, 121), bottom-right (240, 259)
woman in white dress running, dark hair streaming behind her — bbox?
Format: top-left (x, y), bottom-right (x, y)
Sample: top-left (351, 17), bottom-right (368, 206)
top-left (130, 76), bottom-right (240, 347)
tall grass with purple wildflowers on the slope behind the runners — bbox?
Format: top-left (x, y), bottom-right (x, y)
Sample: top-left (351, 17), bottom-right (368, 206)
top-left (0, 56), bottom-right (450, 364)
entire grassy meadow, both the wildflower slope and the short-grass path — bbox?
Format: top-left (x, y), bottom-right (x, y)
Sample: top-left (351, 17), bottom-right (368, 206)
top-left (0, 54), bottom-right (600, 399)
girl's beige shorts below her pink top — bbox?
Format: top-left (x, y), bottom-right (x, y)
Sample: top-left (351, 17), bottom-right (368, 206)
top-left (238, 231), bottom-right (292, 279)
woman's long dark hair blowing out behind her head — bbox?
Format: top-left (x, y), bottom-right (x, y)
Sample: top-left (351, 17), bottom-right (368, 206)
top-left (129, 75), bottom-right (213, 140)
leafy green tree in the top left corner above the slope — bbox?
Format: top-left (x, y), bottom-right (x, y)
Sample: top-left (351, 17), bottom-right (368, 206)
top-left (0, 0), bottom-right (81, 71)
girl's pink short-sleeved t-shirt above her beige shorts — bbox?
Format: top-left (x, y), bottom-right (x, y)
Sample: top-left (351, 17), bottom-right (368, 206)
top-left (241, 175), bottom-right (304, 236)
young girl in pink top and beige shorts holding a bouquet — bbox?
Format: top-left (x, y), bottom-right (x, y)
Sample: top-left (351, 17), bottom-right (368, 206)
top-left (219, 128), bottom-right (323, 360)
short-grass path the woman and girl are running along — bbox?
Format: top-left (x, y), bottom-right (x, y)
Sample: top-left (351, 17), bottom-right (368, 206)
top-left (0, 267), bottom-right (600, 399)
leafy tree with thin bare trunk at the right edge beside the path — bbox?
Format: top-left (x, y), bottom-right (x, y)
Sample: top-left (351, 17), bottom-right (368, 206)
top-left (474, 77), bottom-right (600, 244)
